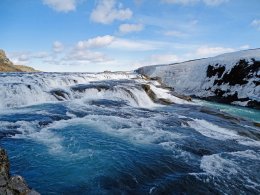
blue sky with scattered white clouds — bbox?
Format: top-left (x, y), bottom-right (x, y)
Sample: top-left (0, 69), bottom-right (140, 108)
top-left (0, 0), bottom-right (260, 72)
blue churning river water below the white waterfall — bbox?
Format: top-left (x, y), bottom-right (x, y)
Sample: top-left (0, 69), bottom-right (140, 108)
top-left (0, 100), bottom-right (260, 194)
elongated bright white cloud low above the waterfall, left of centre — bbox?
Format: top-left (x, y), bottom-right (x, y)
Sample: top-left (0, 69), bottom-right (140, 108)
top-left (77, 35), bottom-right (115, 49)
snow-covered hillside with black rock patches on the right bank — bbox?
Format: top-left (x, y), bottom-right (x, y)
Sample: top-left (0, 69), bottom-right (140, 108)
top-left (136, 49), bottom-right (260, 109)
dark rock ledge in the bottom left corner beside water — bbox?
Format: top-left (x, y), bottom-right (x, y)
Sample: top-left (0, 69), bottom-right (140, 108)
top-left (0, 148), bottom-right (39, 195)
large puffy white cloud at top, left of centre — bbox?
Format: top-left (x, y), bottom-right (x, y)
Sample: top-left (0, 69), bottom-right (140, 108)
top-left (91, 0), bottom-right (133, 24)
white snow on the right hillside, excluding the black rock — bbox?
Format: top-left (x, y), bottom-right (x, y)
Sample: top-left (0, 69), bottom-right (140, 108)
top-left (137, 49), bottom-right (260, 105)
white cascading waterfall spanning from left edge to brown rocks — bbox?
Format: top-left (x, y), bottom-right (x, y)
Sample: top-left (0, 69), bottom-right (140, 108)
top-left (0, 73), bottom-right (191, 109)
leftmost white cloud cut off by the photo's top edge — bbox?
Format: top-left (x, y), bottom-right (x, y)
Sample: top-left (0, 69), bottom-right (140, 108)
top-left (43, 0), bottom-right (78, 12)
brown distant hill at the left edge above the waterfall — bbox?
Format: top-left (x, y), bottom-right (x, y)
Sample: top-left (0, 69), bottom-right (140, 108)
top-left (0, 49), bottom-right (40, 72)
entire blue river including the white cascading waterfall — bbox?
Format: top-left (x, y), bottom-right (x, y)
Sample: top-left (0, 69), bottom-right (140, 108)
top-left (0, 72), bottom-right (260, 194)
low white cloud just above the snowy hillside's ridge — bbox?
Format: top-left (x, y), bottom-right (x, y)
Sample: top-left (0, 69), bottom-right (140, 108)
top-left (196, 46), bottom-right (236, 57)
